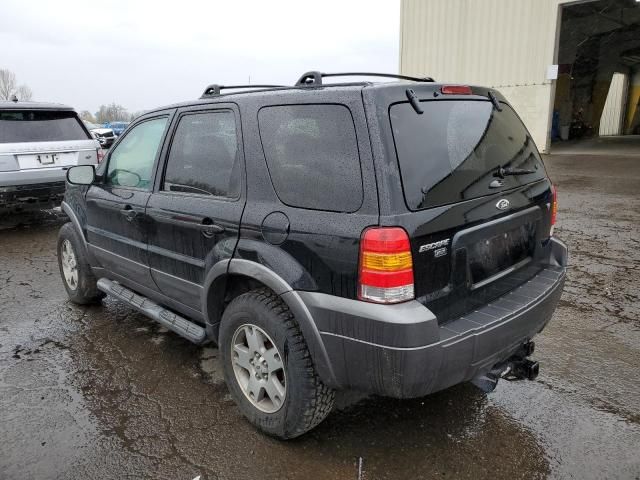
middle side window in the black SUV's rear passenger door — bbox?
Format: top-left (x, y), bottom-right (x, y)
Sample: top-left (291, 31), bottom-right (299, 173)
top-left (163, 110), bottom-right (241, 198)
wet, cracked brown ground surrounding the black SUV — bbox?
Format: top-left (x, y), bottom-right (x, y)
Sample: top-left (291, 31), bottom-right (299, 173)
top-left (0, 155), bottom-right (640, 480)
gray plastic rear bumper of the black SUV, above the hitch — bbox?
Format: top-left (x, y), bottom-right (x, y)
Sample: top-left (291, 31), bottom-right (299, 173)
top-left (298, 239), bottom-right (568, 398)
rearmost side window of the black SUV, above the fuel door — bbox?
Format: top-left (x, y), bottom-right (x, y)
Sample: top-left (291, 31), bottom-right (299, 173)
top-left (258, 105), bottom-right (362, 212)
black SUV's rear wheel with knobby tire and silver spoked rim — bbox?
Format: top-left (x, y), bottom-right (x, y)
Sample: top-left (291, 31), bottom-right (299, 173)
top-left (219, 289), bottom-right (334, 439)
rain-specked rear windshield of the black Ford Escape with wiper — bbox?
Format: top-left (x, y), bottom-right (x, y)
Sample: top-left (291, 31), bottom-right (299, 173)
top-left (389, 100), bottom-right (546, 210)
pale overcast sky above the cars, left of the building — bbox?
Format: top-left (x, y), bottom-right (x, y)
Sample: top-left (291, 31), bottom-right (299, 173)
top-left (0, 0), bottom-right (400, 112)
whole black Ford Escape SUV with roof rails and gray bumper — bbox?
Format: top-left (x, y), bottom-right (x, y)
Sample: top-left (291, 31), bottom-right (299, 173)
top-left (58, 72), bottom-right (567, 438)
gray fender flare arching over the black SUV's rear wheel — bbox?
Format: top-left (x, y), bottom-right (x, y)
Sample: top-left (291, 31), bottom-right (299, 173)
top-left (202, 258), bottom-right (337, 387)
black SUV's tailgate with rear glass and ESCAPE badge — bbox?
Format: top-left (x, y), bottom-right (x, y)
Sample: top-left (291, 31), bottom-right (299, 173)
top-left (378, 95), bottom-right (551, 321)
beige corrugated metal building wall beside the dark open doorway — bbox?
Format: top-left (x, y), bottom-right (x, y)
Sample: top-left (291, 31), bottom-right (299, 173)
top-left (400, 0), bottom-right (568, 150)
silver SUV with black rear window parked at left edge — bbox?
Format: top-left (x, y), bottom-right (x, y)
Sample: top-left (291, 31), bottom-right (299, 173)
top-left (0, 101), bottom-right (99, 214)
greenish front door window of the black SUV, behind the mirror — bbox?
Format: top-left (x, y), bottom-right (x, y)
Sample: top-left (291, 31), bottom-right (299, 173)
top-left (107, 117), bottom-right (167, 190)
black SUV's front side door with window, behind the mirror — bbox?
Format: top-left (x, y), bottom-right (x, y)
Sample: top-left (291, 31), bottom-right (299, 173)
top-left (86, 114), bottom-right (170, 288)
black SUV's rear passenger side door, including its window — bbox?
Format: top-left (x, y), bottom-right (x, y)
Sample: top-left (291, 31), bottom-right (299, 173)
top-left (146, 104), bottom-right (245, 311)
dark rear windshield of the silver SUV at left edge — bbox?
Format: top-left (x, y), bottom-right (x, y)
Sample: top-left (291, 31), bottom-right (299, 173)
top-left (0, 110), bottom-right (90, 143)
